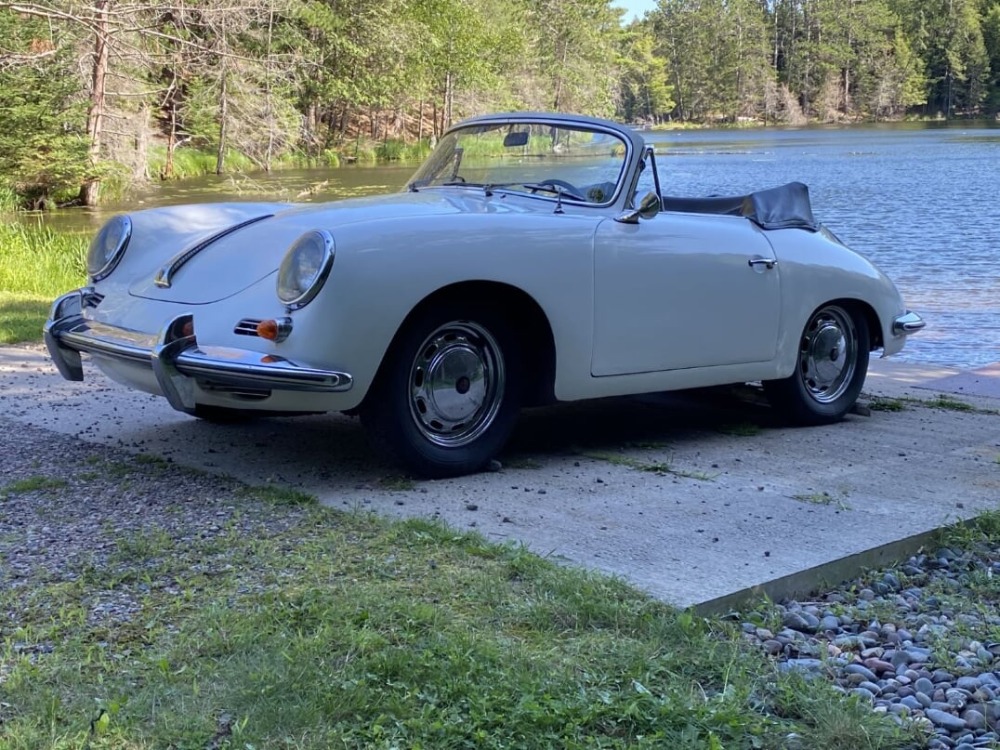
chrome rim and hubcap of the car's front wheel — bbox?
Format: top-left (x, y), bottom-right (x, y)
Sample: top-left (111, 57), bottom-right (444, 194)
top-left (410, 321), bottom-right (505, 448)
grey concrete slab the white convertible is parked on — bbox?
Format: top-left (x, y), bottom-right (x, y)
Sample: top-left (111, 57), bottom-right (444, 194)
top-left (0, 346), bottom-right (1000, 610)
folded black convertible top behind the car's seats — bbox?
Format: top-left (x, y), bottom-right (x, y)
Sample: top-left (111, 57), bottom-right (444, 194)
top-left (661, 182), bottom-right (819, 232)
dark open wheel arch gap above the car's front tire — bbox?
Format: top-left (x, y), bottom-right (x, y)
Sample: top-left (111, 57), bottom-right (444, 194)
top-left (366, 280), bottom-right (556, 406)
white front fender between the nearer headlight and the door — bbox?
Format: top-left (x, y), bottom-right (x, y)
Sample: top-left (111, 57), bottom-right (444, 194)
top-left (278, 214), bottom-right (599, 412)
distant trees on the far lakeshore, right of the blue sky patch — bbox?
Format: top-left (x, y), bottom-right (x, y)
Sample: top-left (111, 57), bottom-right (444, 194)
top-left (619, 0), bottom-right (1000, 124)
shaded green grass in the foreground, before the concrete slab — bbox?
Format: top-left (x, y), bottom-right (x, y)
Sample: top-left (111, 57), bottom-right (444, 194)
top-left (0, 472), bottom-right (913, 750)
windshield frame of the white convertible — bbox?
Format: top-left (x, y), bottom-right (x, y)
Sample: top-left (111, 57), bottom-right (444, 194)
top-left (404, 113), bottom-right (635, 208)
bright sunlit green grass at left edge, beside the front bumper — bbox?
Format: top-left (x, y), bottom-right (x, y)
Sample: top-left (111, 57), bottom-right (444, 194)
top-left (0, 223), bottom-right (89, 344)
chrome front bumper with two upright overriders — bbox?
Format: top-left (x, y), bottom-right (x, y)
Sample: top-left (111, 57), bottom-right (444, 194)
top-left (44, 287), bottom-right (354, 412)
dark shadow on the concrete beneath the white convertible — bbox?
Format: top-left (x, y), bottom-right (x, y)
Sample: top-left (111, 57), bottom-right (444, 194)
top-left (145, 388), bottom-right (782, 492)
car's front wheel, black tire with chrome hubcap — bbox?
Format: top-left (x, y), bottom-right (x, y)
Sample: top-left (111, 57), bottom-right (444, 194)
top-left (361, 301), bottom-right (524, 479)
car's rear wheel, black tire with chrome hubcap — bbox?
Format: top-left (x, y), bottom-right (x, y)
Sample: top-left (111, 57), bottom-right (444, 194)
top-left (764, 304), bottom-right (871, 425)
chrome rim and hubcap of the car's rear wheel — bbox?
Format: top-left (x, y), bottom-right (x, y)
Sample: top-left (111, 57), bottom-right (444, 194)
top-left (799, 306), bottom-right (858, 404)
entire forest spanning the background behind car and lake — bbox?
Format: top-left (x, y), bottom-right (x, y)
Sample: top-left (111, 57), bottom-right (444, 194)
top-left (0, 0), bottom-right (1000, 208)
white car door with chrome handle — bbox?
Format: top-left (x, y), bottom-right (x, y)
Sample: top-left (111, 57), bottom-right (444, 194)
top-left (592, 212), bottom-right (781, 376)
